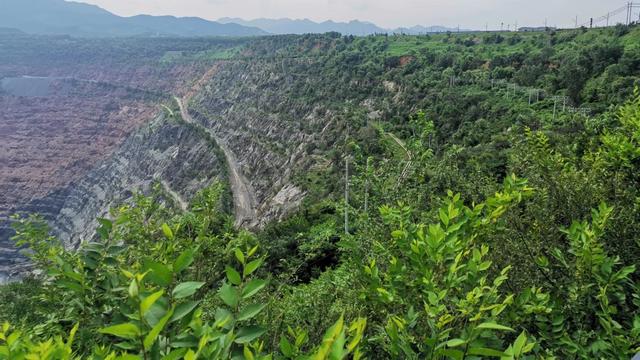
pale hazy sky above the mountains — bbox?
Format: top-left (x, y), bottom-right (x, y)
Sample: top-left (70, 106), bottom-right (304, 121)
top-left (71, 0), bottom-right (638, 29)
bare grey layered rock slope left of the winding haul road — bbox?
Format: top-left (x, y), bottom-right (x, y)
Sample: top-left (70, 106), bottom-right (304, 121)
top-left (0, 115), bottom-right (225, 278)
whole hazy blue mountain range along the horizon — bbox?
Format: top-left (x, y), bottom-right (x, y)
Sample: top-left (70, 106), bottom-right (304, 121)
top-left (0, 0), bottom-right (465, 37)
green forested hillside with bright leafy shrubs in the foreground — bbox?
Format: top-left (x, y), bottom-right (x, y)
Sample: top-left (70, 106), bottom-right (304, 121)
top-left (0, 26), bottom-right (640, 360)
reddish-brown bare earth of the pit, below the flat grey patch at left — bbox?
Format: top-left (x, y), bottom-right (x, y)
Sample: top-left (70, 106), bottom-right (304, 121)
top-left (0, 88), bottom-right (157, 217)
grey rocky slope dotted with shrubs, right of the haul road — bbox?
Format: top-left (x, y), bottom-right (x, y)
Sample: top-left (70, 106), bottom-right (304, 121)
top-left (189, 61), bottom-right (335, 227)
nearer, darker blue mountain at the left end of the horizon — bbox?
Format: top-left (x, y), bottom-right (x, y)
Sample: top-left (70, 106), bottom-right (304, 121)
top-left (0, 0), bottom-right (266, 37)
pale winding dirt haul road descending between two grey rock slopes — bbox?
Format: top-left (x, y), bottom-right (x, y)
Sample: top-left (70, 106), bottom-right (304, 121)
top-left (174, 97), bottom-right (257, 228)
